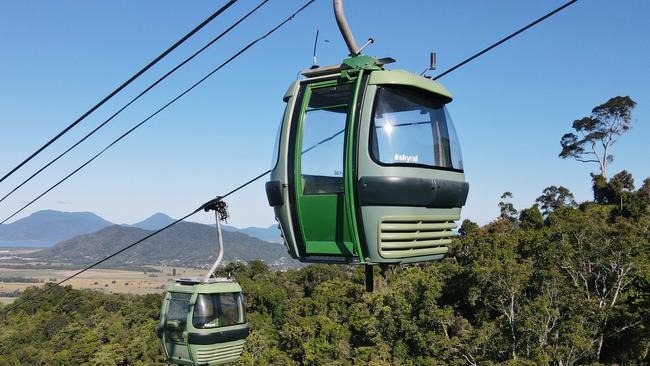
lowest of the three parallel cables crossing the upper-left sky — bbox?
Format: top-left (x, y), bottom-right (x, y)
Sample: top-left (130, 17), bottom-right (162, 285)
top-left (0, 0), bottom-right (316, 225)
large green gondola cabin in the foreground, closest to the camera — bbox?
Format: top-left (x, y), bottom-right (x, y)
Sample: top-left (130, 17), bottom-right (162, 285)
top-left (266, 56), bottom-right (469, 264)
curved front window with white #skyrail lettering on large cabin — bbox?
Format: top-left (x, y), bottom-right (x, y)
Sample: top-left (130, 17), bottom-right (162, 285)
top-left (370, 86), bottom-right (463, 171)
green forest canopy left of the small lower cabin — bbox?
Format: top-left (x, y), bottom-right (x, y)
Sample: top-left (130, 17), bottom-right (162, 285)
top-left (0, 284), bottom-right (165, 365)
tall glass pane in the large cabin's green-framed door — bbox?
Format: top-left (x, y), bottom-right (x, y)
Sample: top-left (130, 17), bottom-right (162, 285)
top-left (300, 83), bottom-right (354, 194)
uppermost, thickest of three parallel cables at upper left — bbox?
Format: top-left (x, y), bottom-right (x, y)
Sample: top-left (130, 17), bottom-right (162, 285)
top-left (0, 0), bottom-right (238, 182)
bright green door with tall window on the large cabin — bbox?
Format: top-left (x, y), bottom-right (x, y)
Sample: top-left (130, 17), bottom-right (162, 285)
top-left (293, 80), bottom-right (356, 257)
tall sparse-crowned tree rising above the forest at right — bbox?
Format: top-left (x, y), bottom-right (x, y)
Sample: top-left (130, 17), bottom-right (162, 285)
top-left (559, 96), bottom-right (636, 176)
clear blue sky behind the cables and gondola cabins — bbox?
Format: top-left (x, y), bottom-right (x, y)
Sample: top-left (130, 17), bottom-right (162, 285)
top-left (0, 0), bottom-right (650, 226)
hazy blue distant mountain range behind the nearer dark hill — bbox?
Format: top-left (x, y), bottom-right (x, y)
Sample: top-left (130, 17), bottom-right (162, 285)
top-left (0, 210), bottom-right (282, 246)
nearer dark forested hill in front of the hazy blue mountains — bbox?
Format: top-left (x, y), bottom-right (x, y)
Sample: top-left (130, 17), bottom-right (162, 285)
top-left (34, 222), bottom-right (298, 268)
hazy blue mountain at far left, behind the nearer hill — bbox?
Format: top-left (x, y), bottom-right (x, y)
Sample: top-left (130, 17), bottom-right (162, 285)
top-left (0, 210), bottom-right (113, 243)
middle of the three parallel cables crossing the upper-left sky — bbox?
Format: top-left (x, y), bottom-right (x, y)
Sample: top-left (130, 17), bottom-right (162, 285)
top-left (0, 0), bottom-right (269, 203)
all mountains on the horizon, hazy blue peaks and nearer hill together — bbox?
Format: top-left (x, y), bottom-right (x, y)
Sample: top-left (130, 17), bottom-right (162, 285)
top-left (0, 210), bottom-right (298, 269)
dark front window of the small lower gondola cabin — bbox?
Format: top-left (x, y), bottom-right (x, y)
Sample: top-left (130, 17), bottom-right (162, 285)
top-left (192, 292), bottom-right (246, 329)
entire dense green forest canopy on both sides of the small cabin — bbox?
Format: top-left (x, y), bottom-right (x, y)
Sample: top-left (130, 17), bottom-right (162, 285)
top-left (0, 174), bottom-right (650, 366)
